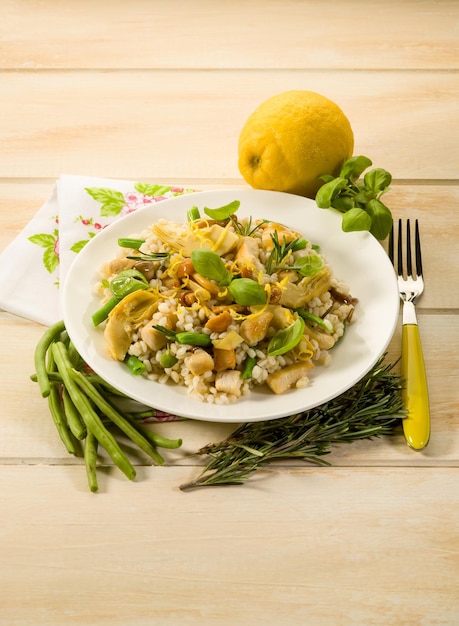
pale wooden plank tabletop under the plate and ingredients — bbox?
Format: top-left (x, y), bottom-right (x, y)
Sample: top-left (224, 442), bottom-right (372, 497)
top-left (0, 0), bottom-right (459, 626)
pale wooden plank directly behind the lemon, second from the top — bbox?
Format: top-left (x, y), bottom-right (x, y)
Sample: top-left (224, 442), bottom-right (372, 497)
top-left (0, 70), bottom-right (459, 182)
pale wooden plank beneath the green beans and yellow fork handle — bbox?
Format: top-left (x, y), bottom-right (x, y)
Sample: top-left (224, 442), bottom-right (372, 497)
top-left (0, 313), bottom-right (459, 464)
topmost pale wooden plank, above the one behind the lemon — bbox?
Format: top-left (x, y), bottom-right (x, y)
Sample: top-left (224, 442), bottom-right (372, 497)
top-left (0, 0), bottom-right (459, 70)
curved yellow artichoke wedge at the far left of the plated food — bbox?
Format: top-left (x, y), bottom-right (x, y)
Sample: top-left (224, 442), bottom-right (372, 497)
top-left (104, 291), bottom-right (158, 361)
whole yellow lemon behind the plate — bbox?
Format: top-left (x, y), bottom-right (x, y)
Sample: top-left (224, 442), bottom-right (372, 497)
top-left (238, 90), bottom-right (354, 198)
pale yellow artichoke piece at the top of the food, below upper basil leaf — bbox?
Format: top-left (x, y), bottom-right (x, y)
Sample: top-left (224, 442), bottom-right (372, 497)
top-left (153, 224), bottom-right (239, 257)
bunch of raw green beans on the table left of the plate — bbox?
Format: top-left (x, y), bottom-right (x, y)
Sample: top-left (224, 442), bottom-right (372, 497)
top-left (31, 321), bottom-right (182, 492)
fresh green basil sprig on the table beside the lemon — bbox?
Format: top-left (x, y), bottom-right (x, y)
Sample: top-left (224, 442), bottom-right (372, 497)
top-left (316, 156), bottom-right (392, 241)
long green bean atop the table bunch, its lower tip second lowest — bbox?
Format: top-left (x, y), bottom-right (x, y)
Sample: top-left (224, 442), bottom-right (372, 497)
top-left (52, 341), bottom-right (136, 480)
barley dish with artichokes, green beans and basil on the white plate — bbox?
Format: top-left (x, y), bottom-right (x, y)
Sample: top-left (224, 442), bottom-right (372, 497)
top-left (93, 201), bottom-right (357, 404)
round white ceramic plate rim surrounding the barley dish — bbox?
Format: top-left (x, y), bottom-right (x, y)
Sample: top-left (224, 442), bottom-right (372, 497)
top-left (62, 189), bottom-right (399, 422)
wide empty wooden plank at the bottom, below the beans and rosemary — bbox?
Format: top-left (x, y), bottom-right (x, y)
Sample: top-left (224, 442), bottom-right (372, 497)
top-left (0, 460), bottom-right (459, 626)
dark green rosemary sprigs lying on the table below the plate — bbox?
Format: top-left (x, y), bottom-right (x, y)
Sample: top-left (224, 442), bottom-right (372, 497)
top-left (180, 355), bottom-right (405, 491)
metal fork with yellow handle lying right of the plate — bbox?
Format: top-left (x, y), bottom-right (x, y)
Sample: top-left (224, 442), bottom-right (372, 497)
top-left (388, 219), bottom-right (430, 450)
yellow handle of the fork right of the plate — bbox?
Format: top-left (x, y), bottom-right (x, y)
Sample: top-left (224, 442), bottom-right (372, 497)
top-left (401, 324), bottom-right (430, 450)
